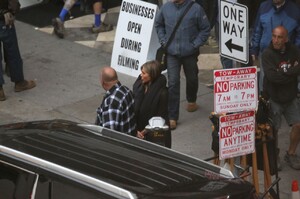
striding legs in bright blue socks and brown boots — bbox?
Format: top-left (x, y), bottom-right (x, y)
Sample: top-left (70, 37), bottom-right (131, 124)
top-left (52, 0), bottom-right (113, 39)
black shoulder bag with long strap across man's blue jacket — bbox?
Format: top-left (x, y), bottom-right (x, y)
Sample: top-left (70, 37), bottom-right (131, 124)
top-left (155, 1), bottom-right (194, 71)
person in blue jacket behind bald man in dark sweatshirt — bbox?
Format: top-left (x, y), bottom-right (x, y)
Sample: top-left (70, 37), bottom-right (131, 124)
top-left (250, 0), bottom-right (300, 94)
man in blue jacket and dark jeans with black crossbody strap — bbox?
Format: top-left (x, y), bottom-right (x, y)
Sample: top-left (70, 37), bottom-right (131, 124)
top-left (155, 0), bottom-right (210, 130)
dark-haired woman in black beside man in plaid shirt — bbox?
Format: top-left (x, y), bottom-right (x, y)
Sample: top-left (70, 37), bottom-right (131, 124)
top-left (133, 61), bottom-right (171, 148)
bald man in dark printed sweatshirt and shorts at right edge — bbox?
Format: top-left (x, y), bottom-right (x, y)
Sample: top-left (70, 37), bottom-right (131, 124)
top-left (262, 26), bottom-right (300, 170)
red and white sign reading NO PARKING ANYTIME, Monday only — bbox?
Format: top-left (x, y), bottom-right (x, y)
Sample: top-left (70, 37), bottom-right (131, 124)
top-left (219, 110), bottom-right (255, 160)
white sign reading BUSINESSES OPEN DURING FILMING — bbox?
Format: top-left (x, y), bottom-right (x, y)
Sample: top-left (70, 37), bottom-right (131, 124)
top-left (111, 0), bottom-right (159, 77)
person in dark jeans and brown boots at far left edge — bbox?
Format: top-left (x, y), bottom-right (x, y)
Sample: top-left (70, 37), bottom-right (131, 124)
top-left (0, 0), bottom-right (36, 101)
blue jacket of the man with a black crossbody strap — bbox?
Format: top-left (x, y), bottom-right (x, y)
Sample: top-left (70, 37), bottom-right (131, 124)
top-left (155, 0), bottom-right (210, 57)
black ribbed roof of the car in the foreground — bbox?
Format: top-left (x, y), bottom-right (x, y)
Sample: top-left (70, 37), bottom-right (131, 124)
top-left (0, 120), bottom-right (255, 198)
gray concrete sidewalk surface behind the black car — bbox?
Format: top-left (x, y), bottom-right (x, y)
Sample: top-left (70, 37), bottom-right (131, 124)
top-left (0, 21), bottom-right (300, 199)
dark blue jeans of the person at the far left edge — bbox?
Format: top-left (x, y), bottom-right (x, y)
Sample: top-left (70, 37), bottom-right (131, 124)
top-left (0, 20), bottom-right (24, 85)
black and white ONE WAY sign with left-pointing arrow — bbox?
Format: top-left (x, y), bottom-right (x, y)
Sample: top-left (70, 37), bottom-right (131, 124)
top-left (219, 0), bottom-right (249, 63)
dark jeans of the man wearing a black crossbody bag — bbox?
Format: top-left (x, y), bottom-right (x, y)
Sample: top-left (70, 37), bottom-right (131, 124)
top-left (167, 53), bottom-right (199, 121)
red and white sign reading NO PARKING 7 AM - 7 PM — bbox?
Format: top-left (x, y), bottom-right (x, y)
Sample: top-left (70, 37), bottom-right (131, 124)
top-left (214, 66), bottom-right (258, 113)
